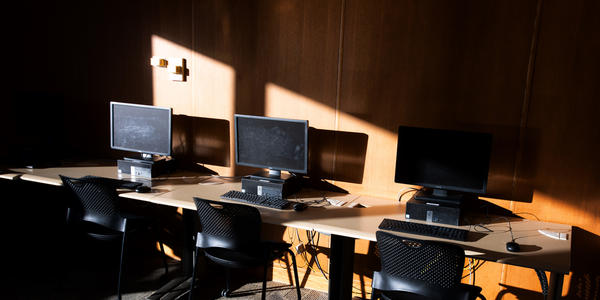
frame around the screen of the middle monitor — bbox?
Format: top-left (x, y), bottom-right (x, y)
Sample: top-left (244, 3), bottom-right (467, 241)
top-left (233, 114), bottom-right (308, 174)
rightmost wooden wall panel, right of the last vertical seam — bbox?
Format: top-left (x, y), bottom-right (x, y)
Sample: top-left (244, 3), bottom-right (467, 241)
top-left (514, 1), bottom-right (600, 298)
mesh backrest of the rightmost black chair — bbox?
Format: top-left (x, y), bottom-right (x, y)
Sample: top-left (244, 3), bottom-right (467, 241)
top-left (376, 231), bottom-right (465, 288)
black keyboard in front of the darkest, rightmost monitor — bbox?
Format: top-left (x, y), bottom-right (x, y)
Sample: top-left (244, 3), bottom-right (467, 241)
top-left (379, 219), bottom-right (469, 241)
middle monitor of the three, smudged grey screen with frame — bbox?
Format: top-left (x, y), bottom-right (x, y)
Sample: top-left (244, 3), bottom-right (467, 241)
top-left (235, 115), bottom-right (308, 174)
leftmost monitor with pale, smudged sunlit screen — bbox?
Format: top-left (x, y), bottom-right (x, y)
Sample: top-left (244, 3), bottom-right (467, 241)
top-left (110, 102), bottom-right (172, 155)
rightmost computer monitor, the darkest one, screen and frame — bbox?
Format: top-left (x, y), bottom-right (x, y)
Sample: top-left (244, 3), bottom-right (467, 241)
top-left (395, 126), bottom-right (492, 194)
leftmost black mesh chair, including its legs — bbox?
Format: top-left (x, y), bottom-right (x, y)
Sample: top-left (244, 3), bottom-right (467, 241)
top-left (60, 175), bottom-right (169, 299)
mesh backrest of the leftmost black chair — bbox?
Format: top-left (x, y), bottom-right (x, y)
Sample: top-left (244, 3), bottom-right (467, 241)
top-left (60, 175), bottom-right (127, 232)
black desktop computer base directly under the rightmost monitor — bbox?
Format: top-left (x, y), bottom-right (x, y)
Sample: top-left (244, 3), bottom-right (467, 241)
top-left (404, 198), bottom-right (461, 226)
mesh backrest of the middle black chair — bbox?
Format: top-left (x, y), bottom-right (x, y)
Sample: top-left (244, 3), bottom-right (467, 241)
top-left (194, 197), bottom-right (262, 251)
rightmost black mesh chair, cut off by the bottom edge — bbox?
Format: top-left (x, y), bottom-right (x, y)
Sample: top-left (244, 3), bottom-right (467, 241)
top-left (371, 231), bottom-right (485, 300)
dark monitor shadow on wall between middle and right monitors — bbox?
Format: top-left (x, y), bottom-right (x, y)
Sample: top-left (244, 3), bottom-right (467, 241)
top-left (308, 127), bottom-right (369, 183)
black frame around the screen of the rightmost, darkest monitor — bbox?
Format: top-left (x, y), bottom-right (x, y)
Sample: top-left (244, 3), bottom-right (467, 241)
top-left (394, 126), bottom-right (493, 195)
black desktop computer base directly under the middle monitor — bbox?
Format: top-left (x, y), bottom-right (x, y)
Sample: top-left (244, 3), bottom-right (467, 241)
top-left (242, 175), bottom-right (300, 198)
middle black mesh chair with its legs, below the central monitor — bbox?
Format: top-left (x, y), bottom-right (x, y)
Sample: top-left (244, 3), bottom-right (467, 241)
top-left (189, 198), bottom-right (300, 299)
